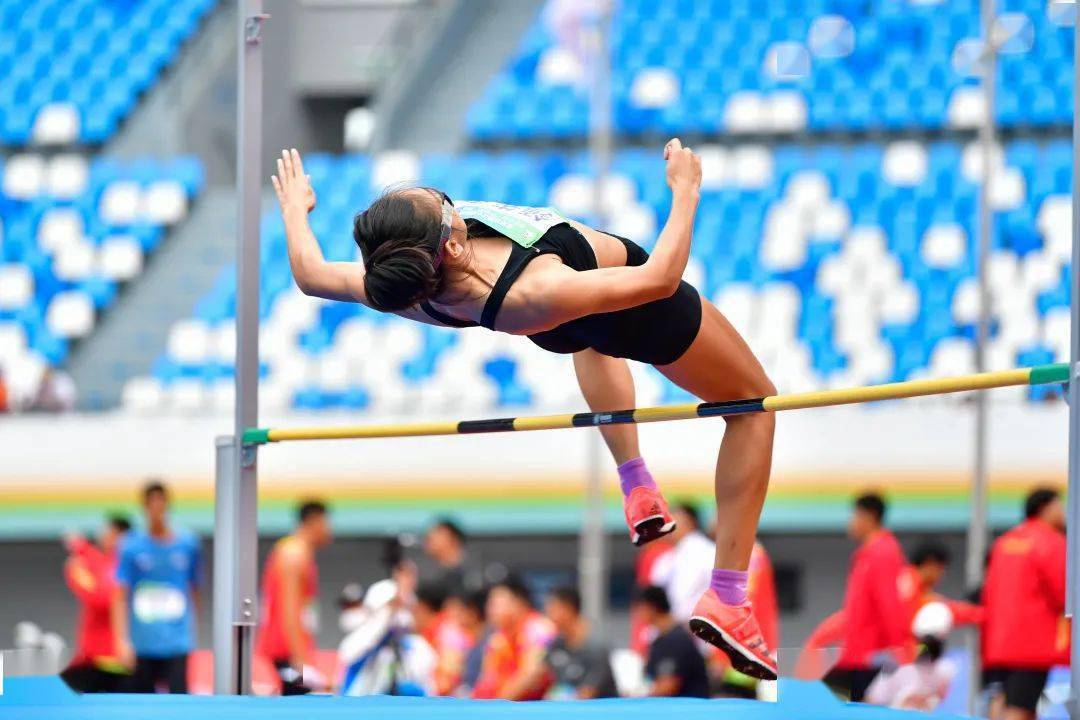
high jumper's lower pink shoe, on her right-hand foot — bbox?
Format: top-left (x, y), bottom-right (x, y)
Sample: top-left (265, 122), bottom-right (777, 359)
top-left (690, 588), bottom-right (777, 680)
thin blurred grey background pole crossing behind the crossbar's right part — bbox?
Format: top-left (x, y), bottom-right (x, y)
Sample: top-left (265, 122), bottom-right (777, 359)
top-left (964, 0), bottom-right (998, 715)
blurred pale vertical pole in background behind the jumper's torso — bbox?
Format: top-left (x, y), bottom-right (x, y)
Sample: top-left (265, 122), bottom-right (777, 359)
top-left (578, 0), bottom-right (613, 631)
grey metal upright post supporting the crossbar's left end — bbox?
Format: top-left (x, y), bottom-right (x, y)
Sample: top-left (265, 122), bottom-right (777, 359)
top-left (214, 0), bottom-right (268, 694)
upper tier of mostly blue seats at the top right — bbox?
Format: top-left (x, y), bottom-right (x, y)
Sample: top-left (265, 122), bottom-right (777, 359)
top-left (469, 0), bottom-right (1075, 141)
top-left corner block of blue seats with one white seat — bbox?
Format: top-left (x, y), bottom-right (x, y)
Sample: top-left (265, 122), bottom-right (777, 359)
top-left (0, 0), bottom-right (214, 146)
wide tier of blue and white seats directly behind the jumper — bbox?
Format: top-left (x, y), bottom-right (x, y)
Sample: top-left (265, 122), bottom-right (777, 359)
top-left (125, 140), bottom-right (1071, 412)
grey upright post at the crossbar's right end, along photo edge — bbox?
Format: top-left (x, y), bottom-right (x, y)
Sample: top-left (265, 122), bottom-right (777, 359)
top-left (1065, 11), bottom-right (1080, 718)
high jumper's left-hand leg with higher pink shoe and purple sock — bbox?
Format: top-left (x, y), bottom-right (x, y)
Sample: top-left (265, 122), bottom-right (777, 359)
top-left (573, 350), bottom-right (675, 545)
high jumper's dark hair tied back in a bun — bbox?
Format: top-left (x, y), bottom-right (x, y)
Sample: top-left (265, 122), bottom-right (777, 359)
top-left (352, 191), bottom-right (443, 312)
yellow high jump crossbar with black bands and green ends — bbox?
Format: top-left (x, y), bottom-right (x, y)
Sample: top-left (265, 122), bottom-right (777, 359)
top-left (243, 363), bottom-right (1068, 446)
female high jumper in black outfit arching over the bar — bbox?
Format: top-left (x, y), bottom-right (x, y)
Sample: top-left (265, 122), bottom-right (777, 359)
top-left (271, 138), bottom-right (777, 679)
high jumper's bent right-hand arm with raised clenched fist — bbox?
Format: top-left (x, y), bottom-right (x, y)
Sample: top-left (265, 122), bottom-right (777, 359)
top-left (536, 138), bottom-right (701, 327)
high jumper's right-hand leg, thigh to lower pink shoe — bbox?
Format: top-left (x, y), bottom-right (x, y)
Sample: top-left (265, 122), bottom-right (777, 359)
top-left (658, 298), bottom-right (775, 679)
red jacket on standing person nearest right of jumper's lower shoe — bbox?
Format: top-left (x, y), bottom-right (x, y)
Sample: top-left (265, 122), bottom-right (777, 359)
top-left (836, 530), bottom-right (910, 670)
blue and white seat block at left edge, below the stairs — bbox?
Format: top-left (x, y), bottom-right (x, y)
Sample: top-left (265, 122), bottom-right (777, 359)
top-left (0, 153), bottom-right (203, 407)
